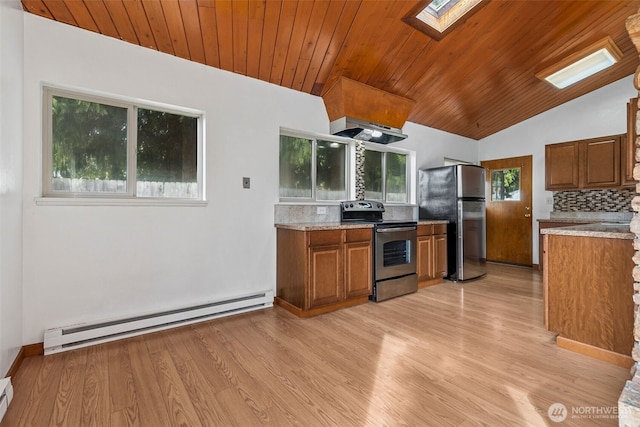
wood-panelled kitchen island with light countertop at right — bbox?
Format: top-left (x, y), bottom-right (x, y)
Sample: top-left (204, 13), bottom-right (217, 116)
top-left (541, 223), bottom-right (634, 367)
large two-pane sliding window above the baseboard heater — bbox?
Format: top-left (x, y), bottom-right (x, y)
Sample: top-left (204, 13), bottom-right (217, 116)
top-left (42, 86), bottom-right (204, 201)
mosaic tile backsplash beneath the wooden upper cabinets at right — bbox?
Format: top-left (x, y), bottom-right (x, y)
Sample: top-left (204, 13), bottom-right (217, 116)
top-left (553, 189), bottom-right (636, 212)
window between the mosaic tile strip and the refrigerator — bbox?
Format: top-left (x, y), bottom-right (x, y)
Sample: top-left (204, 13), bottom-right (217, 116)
top-left (363, 143), bottom-right (412, 204)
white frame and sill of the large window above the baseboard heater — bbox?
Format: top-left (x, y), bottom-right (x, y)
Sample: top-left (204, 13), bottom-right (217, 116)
top-left (42, 85), bottom-right (206, 202)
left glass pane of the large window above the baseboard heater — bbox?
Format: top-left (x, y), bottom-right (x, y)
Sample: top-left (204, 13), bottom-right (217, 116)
top-left (51, 96), bottom-right (127, 193)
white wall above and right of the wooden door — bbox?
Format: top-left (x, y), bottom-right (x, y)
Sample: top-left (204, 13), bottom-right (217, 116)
top-left (478, 76), bottom-right (637, 264)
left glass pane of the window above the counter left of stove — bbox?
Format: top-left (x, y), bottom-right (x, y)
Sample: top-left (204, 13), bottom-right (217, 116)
top-left (280, 135), bottom-right (311, 198)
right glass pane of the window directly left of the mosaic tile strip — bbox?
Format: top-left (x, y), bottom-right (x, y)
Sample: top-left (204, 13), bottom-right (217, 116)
top-left (316, 140), bottom-right (347, 200)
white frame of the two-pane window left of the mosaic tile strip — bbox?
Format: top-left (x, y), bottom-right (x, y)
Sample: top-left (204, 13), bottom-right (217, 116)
top-left (278, 127), bottom-right (355, 204)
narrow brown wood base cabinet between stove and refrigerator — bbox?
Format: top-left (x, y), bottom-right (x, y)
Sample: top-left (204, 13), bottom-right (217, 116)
top-left (417, 224), bottom-right (447, 287)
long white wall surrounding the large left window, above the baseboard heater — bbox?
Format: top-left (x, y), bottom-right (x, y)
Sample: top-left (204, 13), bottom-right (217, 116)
top-left (24, 13), bottom-right (329, 344)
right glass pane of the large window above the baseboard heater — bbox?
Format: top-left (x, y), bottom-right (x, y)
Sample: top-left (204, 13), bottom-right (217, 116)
top-left (136, 108), bottom-right (198, 198)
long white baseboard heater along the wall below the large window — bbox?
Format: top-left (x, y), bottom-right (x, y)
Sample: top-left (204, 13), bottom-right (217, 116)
top-left (44, 291), bottom-right (273, 355)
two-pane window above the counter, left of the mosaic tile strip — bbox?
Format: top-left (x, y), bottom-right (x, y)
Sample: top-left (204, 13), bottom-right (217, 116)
top-left (279, 129), bottom-right (354, 202)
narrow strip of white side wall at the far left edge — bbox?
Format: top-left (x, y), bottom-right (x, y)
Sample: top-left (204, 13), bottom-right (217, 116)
top-left (0, 1), bottom-right (23, 377)
